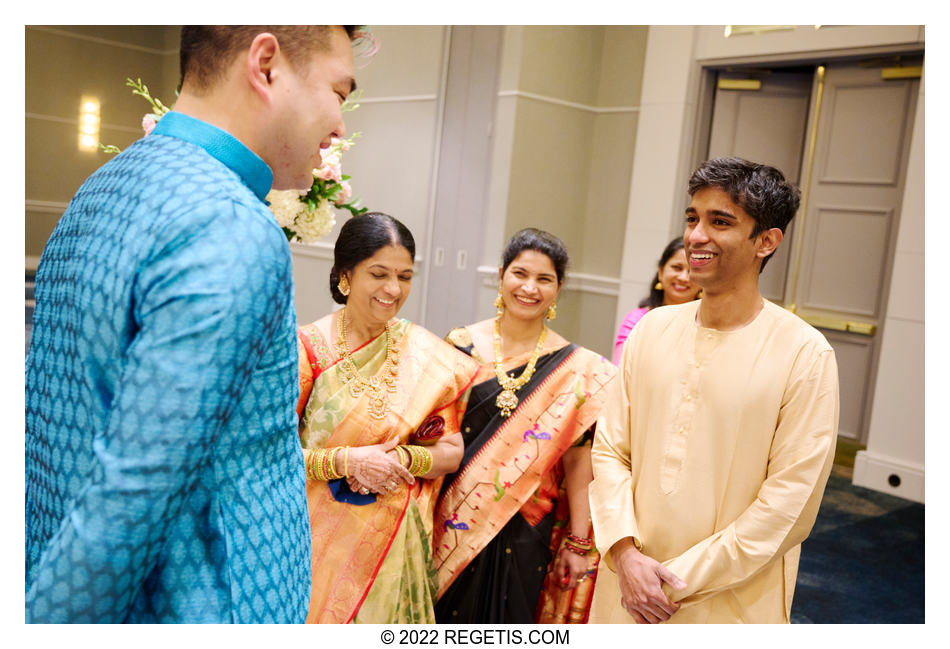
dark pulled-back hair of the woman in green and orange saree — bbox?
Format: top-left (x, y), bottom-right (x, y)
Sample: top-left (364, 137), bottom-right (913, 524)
top-left (330, 212), bottom-right (416, 304)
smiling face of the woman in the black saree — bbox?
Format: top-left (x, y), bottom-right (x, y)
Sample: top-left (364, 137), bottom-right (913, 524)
top-left (498, 250), bottom-right (561, 320)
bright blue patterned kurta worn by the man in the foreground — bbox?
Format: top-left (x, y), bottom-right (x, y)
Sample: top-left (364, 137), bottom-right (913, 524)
top-left (26, 113), bottom-right (310, 622)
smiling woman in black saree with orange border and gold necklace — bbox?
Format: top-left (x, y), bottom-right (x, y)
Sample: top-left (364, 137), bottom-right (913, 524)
top-left (433, 228), bottom-right (616, 624)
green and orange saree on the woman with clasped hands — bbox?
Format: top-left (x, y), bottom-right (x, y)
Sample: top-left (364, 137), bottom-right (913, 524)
top-left (297, 316), bottom-right (477, 623)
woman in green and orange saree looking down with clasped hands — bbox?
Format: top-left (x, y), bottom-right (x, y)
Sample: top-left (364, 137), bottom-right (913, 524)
top-left (297, 213), bottom-right (477, 624)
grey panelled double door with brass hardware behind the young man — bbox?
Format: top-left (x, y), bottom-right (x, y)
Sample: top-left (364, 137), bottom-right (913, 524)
top-left (706, 61), bottom-right (919, 442)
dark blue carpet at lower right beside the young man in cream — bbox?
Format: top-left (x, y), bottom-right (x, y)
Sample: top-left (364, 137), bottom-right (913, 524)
top-left (792, 473), bottom-right (924, 624)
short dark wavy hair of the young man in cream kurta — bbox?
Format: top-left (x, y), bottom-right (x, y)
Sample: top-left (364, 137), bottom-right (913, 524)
top-left (689, 158), bottom-right (801, 272)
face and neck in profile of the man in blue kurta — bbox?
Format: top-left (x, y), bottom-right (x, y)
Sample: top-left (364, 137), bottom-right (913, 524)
top-left (265, 27), bottom-right (355, 189)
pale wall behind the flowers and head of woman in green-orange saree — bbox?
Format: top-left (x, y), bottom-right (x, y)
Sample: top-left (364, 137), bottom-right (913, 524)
top-left (291, 25), bottom-right (448, 322)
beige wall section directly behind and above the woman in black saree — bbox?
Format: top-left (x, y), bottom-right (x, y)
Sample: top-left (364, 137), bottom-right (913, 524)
top-left (479, 26), bottom-right (647, 356)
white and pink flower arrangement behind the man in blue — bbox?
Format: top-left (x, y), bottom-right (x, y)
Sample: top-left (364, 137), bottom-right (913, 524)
top-left (99, 79), bottom-right (366, 244)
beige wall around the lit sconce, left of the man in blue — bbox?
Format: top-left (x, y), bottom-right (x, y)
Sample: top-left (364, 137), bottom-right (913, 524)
top-left (25, 26), bottom-right (178, 267)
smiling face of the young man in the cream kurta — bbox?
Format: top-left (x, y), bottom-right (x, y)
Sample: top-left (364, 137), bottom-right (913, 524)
top-left (683, 186), bottom-right (782, 294)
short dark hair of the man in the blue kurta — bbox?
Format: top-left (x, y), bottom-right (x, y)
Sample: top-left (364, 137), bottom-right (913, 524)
top-left (179, 25), bottom-right (358, 92)
